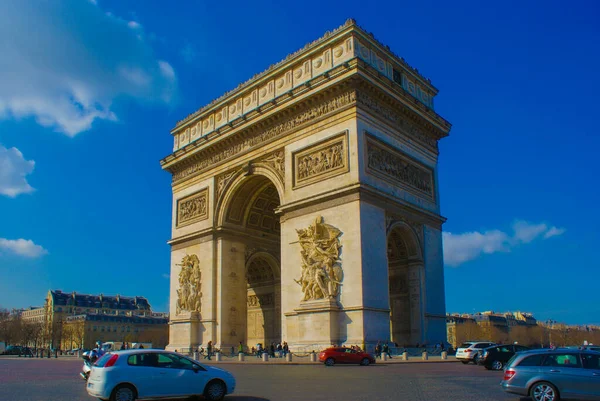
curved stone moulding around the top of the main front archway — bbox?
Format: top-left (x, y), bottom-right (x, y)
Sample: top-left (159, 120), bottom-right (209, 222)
top-left (214, 163), bottom-right (285, 227)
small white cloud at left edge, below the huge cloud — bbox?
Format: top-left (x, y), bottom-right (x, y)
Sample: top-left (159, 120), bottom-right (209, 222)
top-left (0, 145), bottom-right (35, 198)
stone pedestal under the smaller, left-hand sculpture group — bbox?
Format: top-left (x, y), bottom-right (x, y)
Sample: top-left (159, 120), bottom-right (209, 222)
top-left (165, 312), bottom-right (202, 353)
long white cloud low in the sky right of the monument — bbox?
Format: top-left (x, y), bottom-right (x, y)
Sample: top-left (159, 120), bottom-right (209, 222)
top-left (442, 220), bottom-right (566, 267)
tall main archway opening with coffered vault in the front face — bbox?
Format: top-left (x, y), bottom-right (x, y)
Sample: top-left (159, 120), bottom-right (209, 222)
top-left (224, 175), bottom-right (282, 348)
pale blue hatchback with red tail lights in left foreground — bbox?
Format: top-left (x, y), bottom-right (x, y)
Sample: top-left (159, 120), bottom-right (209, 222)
top-left (87, 349), bottom-right (235, 401)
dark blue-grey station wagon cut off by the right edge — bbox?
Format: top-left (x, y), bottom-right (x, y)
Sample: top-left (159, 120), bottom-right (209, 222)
top-left (501, 348), bottom-right (600, 401)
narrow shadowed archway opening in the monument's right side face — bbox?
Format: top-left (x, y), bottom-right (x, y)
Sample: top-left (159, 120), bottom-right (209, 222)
top-left (387, 226), bottom-right (423, 346)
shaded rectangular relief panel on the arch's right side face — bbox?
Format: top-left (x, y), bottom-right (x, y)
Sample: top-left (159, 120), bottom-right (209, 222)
top-left (365, 134), bottom-right (435, 200)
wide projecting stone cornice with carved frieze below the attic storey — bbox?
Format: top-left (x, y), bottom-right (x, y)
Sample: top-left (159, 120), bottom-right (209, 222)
top-left (161, 73), bottom-right (450, 184)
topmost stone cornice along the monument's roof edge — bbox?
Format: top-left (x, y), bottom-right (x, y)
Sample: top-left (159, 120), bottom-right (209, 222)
top-left (172, 19), bottom-right (437, 133)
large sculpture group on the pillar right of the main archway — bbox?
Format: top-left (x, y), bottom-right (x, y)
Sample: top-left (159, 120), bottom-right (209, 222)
top-left (294, 216), bottom-right (343, 301)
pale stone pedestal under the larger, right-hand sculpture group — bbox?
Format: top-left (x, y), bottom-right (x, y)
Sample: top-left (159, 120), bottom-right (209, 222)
top-left (286, 298), bottom-right (342, 352)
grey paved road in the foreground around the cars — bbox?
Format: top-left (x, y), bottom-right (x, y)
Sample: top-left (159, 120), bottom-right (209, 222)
top-left (0, 358), bottom-right (520, 401)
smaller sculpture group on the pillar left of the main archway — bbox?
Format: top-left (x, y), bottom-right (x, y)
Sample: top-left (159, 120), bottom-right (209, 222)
top-left (175, 255), bottom-right (202, 315)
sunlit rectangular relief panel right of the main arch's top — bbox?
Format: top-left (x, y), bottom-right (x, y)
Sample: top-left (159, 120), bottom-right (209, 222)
top-left (293, 131), bottom-right (348, 188)
